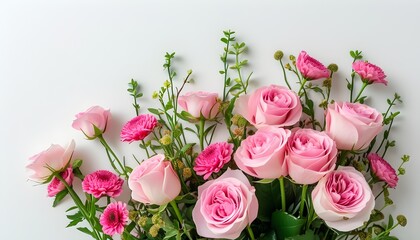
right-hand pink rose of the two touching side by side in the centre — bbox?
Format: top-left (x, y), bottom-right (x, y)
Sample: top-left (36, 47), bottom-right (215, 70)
top-left (286, 128), bottom-right (338, 184)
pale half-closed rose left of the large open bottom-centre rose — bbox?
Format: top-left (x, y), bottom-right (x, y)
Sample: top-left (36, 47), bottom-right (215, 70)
top-left (128, 154), bottom-right (181, 205)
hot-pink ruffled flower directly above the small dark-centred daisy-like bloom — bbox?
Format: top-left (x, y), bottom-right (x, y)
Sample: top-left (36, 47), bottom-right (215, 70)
top-left (82, 170), bottom-right (124, 198)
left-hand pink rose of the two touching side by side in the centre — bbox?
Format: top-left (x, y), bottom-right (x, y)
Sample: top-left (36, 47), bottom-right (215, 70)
top-left (234, 126), bottom-right (291, 178)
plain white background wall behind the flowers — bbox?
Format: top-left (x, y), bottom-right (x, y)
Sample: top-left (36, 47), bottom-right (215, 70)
top-left (0, 0), bottom-right (420, 240)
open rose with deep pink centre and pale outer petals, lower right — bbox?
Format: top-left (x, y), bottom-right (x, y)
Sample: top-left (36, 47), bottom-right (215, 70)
top-left (312, 166), bottom-right (375, 232)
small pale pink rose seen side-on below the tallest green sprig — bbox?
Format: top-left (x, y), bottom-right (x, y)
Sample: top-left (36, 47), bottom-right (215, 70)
top-left (178, 91), bottom-right (220, 119)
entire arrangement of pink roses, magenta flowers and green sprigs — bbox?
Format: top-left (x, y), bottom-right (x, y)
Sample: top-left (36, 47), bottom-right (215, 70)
top-left (27, 31), bottom-right (409, 240)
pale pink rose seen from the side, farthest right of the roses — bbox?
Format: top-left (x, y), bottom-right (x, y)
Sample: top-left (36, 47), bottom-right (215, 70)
top-left (325, 102), bottom-right (383, 150)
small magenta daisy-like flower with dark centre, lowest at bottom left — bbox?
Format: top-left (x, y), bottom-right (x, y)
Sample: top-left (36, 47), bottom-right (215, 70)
top-left (99, 202), bottom-right (128, 236)
